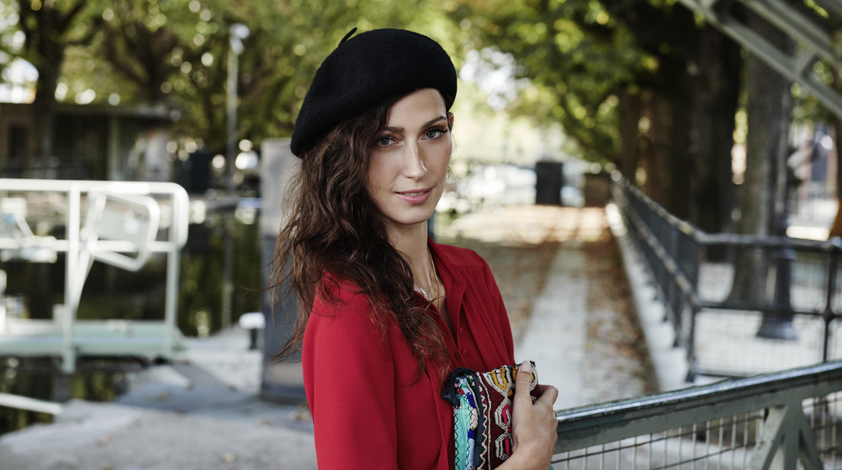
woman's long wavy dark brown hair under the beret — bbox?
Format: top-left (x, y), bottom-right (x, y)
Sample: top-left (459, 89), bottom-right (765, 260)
top-left (273, 93), bottom-right (452, 377)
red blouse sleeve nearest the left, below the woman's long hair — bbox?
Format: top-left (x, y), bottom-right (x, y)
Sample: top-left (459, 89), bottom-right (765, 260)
top-left (302, 295), bottom-right (398, 470)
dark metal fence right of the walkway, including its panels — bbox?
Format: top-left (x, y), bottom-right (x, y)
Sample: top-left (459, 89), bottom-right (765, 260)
top-left (612, 181), bottom-right (842, 380)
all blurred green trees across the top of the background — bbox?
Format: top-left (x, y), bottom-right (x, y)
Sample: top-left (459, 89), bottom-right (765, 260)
top-left (0, 0), bottom-right (834, 232)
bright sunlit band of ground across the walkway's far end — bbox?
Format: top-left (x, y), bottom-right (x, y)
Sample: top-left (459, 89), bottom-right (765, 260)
top-left (443, 206), bottom-right (608, 246)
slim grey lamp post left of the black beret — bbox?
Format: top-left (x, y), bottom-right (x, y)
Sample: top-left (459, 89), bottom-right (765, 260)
top-left (220, 23), bottom-right (249, 328)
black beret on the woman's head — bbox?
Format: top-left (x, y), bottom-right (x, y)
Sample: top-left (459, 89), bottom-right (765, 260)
top-left (291, 29), bottom-right (456, 156)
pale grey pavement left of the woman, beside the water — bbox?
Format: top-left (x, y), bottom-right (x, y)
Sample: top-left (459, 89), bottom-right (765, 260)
top-left (0, 327), bottom-right (317, 470)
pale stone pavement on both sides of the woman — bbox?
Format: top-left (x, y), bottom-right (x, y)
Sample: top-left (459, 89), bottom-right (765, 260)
top-left (0, 206), bottom-right (656, 470)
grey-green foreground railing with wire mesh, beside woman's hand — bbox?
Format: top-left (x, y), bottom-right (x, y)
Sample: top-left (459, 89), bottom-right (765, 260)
top-left (553, 362), bottom-right (842, 470)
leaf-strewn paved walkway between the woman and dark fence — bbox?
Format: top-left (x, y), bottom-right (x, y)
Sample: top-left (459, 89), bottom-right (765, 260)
top-left (445, 206), bottom-right (658, 409)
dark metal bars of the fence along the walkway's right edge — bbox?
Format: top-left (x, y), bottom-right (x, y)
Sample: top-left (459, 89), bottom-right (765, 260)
top-left (612, 180), bottom-right (842, 381)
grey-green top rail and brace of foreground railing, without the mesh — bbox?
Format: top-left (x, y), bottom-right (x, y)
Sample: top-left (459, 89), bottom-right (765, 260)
top-left (555, 361), bottom-right (842, 470)
